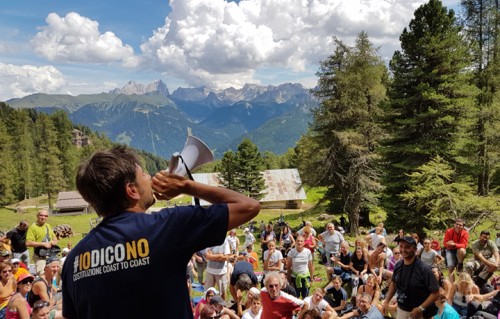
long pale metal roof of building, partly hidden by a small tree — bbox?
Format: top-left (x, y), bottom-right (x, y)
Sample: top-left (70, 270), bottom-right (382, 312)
top-left (193, 168), bottom-right (307, 202)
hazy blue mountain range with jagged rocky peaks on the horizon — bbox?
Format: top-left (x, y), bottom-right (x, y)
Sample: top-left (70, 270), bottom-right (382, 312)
top-left (6, 80), bottom-right (318, 159)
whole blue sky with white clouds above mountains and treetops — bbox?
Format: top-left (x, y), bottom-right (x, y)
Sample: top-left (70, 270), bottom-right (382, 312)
top-left (0, 0), bottom-right (459, 100)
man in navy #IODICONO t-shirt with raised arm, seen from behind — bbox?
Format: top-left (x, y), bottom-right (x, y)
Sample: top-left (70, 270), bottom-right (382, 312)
top-left (62, 146), bottom-right (260, 319)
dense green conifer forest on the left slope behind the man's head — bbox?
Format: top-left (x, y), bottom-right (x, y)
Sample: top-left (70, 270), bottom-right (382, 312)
top-left (0, 102), bottom-right (168, 208)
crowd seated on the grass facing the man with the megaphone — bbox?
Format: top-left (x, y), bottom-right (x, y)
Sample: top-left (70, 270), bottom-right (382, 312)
top-left (0, 215), bottom-right (500, 319)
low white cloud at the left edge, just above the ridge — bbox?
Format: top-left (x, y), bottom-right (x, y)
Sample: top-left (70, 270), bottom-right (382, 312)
top-left (0, 63), bottom-right (65, 98)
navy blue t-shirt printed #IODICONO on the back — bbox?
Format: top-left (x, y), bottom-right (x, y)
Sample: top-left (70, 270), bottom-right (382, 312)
top-left (62, 204), bottom-right (229, 319)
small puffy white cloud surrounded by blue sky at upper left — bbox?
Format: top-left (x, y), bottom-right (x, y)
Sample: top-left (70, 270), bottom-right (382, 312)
top-left (31, 12), bottom-right (134, 64)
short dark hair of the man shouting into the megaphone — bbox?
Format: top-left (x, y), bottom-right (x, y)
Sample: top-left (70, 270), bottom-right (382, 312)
top-left (76, 145), bottom-right (141, 217)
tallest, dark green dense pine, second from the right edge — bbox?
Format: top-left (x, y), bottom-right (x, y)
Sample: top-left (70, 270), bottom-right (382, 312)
top-left (384, 0), bottom-right (475, 228)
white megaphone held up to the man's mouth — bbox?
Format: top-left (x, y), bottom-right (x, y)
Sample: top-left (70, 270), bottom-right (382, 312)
top-left (168, 135), bottom-right (214, 178)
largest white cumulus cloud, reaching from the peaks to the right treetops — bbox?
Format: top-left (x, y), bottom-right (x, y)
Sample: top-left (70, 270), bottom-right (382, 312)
top-left (141, 0), bottom-right (425, 87)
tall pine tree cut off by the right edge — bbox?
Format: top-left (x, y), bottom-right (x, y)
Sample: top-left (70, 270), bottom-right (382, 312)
top-left (458, 0), bottom-right (500, 195)
